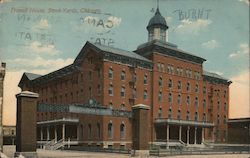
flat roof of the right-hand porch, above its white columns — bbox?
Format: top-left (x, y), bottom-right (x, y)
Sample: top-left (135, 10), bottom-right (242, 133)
top-left (155, 118), bottom-right (214, 127)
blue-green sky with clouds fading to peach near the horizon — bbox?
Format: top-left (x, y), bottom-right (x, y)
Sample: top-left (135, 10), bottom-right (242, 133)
top-left (0, 0), bottom-right (250, 125)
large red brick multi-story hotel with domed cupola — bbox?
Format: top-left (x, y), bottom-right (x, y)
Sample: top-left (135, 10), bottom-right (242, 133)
top-left (19, 6), bottom-right (231, 148)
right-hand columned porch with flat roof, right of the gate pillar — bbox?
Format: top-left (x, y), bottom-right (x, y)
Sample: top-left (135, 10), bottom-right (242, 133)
top-left (154, 118), bottom-right (214, 147)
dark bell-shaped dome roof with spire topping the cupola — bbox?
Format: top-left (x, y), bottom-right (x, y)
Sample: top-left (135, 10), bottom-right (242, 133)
top-left (147, 7), bottom-right (168, 30)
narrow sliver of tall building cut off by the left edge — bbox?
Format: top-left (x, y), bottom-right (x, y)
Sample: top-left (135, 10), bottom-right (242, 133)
top-left (0, 61), bottom-right (6, 152)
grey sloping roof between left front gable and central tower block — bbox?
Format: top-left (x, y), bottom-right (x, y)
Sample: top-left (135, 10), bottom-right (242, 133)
top-left (91, 43), bottom-right (151, 62)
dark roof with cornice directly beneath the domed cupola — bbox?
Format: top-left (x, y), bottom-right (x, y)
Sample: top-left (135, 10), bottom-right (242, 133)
top-left (135, 40), bottom-right (206, 64)
